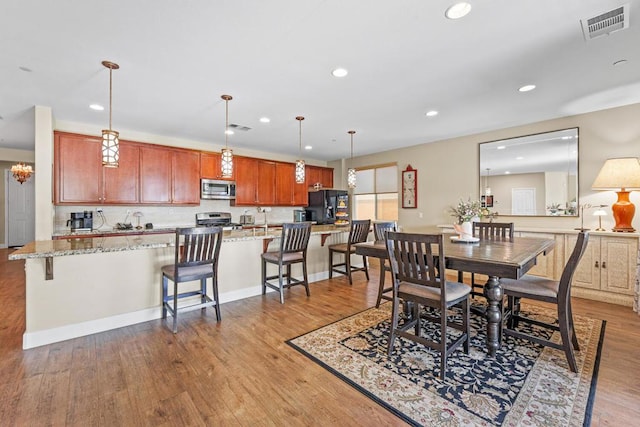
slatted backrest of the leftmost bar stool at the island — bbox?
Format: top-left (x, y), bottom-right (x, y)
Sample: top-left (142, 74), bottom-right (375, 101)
top-left (175, 227), bottom-right (222, 271)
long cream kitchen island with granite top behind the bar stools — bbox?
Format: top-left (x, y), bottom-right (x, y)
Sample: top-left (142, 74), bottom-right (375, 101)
top-left (9, 225), bottom-right (349, 349)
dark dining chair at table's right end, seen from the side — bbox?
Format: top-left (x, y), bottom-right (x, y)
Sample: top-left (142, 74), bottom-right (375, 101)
top-left (500, 231), bottom-right (589, 372)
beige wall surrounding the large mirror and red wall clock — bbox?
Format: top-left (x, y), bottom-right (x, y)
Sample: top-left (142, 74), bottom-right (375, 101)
top-left (329, 104), bottom-right (640, 229)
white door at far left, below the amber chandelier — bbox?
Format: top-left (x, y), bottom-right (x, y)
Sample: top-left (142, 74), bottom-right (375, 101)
top-left (5, 170), bottom-right (36, 247)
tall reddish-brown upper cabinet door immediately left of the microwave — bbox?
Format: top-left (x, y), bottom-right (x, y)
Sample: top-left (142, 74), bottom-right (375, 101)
top-left (171, 150), bottom-right (200, 205)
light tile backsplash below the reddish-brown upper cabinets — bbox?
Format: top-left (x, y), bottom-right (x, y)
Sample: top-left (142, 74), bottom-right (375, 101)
top-left (54, 200), bottom-right (301, 232)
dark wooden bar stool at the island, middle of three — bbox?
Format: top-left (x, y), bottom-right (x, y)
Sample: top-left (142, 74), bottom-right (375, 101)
top-left (261, 222), bottom-right (311, 304)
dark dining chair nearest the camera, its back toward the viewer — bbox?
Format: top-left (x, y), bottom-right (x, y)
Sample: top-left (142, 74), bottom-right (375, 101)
top-left (386, 232), bottom-right (471, 379)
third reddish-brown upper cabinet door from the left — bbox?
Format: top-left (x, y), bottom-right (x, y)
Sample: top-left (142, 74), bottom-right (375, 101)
top-left (140, 146), bottom-right (172, 204)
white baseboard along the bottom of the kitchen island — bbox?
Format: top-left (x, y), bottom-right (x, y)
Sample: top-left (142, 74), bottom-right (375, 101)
top-left (22, 271), bottom-right (336, 350)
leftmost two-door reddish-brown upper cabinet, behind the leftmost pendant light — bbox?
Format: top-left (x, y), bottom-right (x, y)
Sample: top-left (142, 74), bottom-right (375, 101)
top-left (54, 132), bottom-right (139, 205)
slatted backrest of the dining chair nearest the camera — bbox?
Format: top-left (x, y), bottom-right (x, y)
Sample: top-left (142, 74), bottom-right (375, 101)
top-left (386, 231), bottom-right (446, 303)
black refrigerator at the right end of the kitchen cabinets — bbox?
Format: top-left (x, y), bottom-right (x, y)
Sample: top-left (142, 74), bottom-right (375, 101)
top-left (305, 190), bottom-right (349, 225)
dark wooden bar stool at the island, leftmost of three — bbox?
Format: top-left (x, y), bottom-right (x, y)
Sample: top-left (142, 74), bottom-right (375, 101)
top-left (161, 227), bottom-right (222, 334)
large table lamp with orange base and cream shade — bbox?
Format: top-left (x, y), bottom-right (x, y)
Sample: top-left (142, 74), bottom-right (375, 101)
top-left (591, 157), bottom-right (640, 232)
